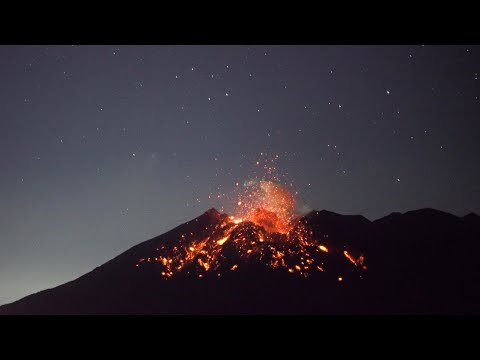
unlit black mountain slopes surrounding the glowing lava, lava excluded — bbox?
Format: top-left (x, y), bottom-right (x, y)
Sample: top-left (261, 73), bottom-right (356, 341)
top-left (0, 208), bottom-right (480, 314)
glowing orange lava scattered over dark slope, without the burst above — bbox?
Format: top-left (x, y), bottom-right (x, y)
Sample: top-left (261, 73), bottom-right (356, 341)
top-left (136, 201), bottom-right (366, 281)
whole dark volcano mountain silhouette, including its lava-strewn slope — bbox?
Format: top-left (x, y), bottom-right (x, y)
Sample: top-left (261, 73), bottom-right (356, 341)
top-left (0, 209), bottom-right (480, 314)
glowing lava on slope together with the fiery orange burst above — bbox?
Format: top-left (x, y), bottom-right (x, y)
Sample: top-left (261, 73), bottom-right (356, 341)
top-left (136, 176), bottom-right (366, 282)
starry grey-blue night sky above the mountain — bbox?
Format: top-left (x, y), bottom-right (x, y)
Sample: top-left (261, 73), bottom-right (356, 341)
top-left (0, 45), bottom-right (480, 304)
